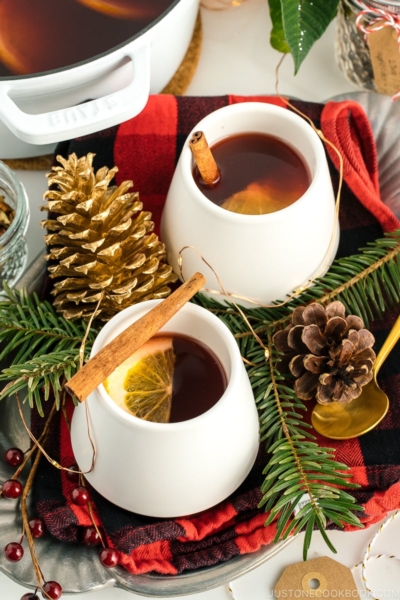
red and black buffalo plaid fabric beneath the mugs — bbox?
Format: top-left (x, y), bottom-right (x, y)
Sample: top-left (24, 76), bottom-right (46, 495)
top-left (32, 96), bottom-right (400, 575)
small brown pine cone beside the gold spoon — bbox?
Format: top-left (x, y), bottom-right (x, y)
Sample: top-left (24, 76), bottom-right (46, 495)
top-left (273, 301), bottom-right (376, 404)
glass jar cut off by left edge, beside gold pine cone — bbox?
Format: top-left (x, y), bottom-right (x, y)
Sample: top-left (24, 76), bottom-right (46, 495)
top-left (0, 161), bottom-right (29, 289)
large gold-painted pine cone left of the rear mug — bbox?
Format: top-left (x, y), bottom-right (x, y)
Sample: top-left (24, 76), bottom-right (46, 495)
top-left (41, 153), bottom-right (177, 321)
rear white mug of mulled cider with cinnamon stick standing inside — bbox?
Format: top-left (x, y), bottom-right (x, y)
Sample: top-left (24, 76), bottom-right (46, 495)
top-left (161, 102), bottom-right (339, 307)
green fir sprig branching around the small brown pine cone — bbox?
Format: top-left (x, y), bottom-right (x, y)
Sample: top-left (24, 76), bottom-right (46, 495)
top-left (197, 230), bottom-right (400, 559)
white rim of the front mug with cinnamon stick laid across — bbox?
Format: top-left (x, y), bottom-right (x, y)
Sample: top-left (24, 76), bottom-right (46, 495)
top-left (90, 300), bottom-right (244, 435)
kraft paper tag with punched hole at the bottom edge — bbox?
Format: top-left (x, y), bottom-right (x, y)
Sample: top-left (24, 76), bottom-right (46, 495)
top-left (274, 556), bottom-right (360, 600)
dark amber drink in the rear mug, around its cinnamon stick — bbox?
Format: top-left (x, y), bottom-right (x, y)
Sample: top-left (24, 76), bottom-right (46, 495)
top-left (193, 133), bottom-right (311, 212)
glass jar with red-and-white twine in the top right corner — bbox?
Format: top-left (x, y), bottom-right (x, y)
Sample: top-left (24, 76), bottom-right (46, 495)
top-left (335, 0), bottom-right (400, 92)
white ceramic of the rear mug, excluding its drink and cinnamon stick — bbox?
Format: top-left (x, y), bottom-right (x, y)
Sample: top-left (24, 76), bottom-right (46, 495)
top-left (161, 102), bottom-right (339, 305)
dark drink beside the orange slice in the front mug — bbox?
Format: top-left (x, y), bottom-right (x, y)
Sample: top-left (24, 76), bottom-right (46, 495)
top-left (165, 333), bottom-right (227, 423)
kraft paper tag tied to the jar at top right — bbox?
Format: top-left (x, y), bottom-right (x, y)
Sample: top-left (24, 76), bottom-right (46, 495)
top-left (368, 21), bottom-right (400, 96)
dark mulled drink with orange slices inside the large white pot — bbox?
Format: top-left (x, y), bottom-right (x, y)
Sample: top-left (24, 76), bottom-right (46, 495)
top-left (0, 0), bottom-right (173, 77)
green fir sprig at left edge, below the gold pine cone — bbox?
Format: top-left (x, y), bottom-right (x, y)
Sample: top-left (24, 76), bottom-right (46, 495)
top-left (0, 283), bottom-right (97, 415)
